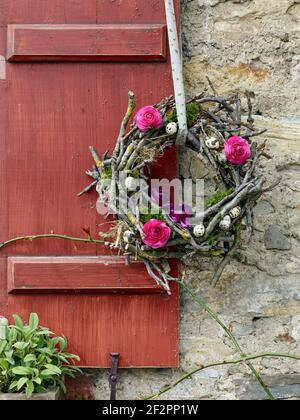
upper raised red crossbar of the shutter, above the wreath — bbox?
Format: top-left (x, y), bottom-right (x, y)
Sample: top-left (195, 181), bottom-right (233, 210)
top-left (7, 24), bottom-right (167, 62)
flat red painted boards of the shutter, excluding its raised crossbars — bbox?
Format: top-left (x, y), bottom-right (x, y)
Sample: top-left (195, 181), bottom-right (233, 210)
top-left (0, 0), bottom-right (179, 367)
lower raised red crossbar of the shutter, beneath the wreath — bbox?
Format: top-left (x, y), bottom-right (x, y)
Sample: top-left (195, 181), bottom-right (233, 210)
top-left (8, 256), bottom-right (163, 294)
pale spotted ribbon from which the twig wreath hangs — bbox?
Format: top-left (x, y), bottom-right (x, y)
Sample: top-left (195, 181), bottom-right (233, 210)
top-left (165, 0), bottom-right (187, 132)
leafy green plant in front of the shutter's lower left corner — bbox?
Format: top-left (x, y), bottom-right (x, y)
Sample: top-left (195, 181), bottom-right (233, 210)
top-left (0, 313), bottom-right (81, 397)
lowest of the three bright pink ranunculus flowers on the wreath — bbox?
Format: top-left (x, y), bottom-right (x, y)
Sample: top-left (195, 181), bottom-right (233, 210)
top-left (144, 219), bottom-right (171, 249)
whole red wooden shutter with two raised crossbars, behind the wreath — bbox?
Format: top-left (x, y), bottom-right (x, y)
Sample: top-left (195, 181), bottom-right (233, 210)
top-left (0, 0), bottom-right (178, 367)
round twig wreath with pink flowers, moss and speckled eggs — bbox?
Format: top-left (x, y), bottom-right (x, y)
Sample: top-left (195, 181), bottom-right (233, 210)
top-left (79, 92), bottom-right (272, 293)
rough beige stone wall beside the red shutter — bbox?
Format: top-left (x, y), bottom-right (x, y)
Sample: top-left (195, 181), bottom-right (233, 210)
top-left (79, 0), bottom-right (300, 399)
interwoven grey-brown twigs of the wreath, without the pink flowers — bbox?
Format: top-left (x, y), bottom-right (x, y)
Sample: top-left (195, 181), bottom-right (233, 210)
top-left (79, 88), bottom-right (274, 293)
